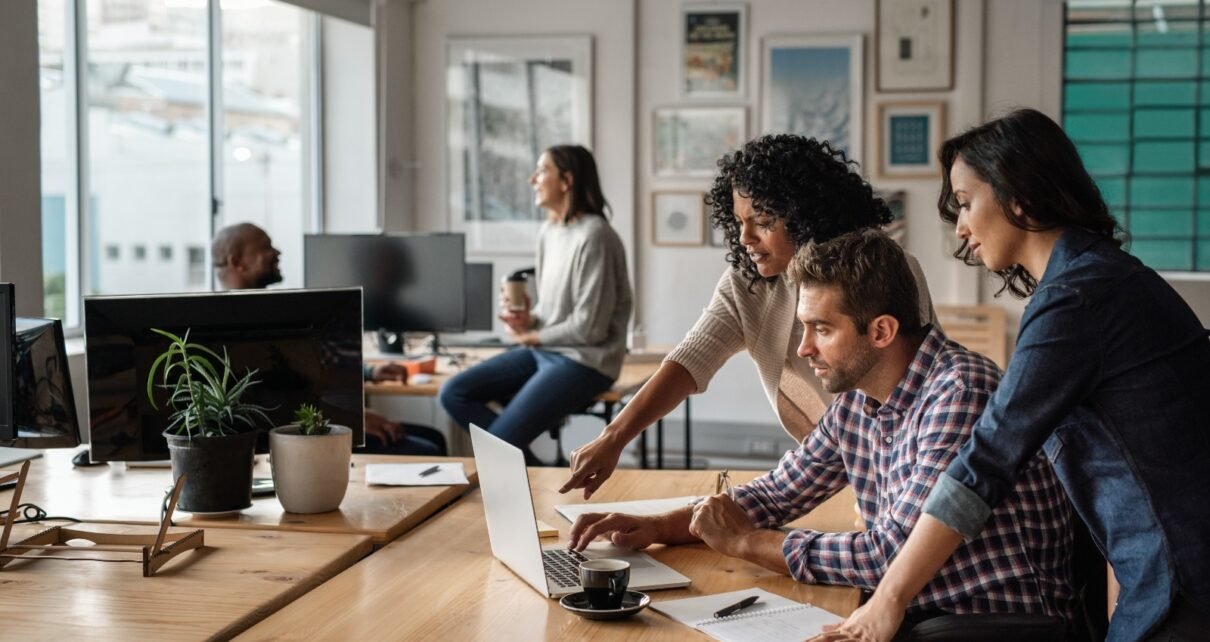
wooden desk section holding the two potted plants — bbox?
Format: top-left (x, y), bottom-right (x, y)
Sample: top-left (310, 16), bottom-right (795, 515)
top-left (0, 450), bottom-right (479, 548)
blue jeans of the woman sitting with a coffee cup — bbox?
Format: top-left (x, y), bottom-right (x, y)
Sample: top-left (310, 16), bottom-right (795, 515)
top-left (440, 348), bottom-right (613, 453)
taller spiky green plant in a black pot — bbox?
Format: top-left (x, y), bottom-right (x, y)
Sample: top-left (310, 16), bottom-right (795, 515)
top-left (148, 328), bottom-right (271, 513)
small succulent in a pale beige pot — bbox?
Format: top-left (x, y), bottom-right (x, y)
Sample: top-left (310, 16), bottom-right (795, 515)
top-left (269, 404), bottom-right (353, 513)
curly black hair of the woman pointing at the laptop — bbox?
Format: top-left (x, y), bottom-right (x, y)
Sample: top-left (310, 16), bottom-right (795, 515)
top-left (705, 134), bottom-right (891, 289)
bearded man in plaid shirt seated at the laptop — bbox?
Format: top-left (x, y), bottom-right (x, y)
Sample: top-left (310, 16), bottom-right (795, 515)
top-left (571, 230), bottom-right (1073, 632)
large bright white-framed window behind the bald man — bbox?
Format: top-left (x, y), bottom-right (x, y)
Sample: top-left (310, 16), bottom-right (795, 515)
top-left (39, 0), bottom-right (319, 329)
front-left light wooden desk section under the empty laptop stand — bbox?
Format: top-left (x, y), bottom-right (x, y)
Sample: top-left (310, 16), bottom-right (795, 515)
top-left (0, 525), bottom-right (371, 642)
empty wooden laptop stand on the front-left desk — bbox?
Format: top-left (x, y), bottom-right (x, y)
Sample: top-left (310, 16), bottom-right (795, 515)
top-left (0, 461), bottom-right (204, 578)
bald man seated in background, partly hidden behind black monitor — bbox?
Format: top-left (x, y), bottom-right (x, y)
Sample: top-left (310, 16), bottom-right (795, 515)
top-left (211, 222), bottom-right (445, 456)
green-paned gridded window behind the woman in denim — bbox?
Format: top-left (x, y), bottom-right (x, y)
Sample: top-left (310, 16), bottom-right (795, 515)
top-left (1062, 0), bottom-right (1210, 272)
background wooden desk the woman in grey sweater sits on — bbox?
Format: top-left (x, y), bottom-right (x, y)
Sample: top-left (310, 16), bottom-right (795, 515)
top-left (365, 348), bottom-right (693, 469)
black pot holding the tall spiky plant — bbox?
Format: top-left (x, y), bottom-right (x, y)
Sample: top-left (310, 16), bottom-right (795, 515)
top-left (165, 433), bottom-right (257, 513)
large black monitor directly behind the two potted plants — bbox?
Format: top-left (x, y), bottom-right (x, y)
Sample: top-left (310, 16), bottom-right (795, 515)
top-left (83, 288), bottom-right (365, 462)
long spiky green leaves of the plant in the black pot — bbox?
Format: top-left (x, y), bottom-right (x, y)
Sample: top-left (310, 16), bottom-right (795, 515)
top-left (148, 328), bottom-right (272, 438)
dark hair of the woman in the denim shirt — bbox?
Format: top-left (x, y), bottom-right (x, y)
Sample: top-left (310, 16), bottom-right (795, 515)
top-left (937, 109), bottom-right (1127, 297)
